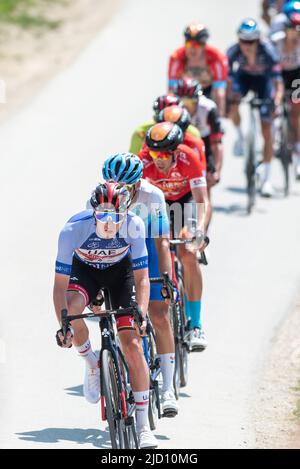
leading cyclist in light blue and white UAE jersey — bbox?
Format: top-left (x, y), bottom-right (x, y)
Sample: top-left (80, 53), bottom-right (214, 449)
top-left (53, 183), bottom-right (157, 448)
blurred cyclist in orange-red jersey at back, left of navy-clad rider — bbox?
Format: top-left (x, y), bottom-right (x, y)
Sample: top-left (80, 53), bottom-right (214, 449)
top-left (169, 23), bottom-right (228, 116)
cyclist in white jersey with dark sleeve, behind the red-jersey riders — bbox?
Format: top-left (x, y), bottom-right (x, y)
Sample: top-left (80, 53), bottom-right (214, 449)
top-left (171, 78), bottom-right (224, 226)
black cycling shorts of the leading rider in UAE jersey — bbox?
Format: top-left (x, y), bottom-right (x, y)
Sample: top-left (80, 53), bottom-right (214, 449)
top-left (68, 257), bottom-right (135, 330)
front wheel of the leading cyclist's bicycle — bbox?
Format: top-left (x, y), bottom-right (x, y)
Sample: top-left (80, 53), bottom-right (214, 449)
top-left (101, 350), bottom-right (125, 449)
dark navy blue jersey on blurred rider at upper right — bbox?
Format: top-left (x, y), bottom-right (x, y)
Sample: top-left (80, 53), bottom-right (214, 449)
top-left (227, 41), bottom-right (281, 80)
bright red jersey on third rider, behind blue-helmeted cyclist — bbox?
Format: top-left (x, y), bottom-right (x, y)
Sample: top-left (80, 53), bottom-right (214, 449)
top-left (139, 144), bottom-right (206, 201)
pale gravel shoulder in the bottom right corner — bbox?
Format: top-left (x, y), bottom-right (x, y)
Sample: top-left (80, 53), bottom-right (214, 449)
top-left (254, 296), bottom-right (300, 449)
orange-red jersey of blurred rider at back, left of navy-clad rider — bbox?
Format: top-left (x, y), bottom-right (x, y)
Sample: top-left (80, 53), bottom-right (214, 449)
top-left (169, 44), bottom-right (228, 89)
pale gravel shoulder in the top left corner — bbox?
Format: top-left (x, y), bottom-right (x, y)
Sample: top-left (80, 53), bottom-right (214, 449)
top-left (0, 0), bottom-right (120, 121)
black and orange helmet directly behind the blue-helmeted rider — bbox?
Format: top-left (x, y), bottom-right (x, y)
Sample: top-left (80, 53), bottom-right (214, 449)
top-left (146, 122), bottom-right (183, 151)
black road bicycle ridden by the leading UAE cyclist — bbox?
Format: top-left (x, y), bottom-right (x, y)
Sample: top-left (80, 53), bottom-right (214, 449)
top-left (61, 289), bottom-right (143, 449)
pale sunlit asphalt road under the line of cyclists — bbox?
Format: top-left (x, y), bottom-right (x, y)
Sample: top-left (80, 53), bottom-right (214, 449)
top-left (0, 0), bottom-right (300, 449)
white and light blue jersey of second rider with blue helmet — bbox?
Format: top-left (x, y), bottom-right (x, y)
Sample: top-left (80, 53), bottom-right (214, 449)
top-left (130, 179), bottom-right (170, 238)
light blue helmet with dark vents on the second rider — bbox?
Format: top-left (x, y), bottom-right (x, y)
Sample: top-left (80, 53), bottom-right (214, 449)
top-left (102, 153), bottom-right (143, 184)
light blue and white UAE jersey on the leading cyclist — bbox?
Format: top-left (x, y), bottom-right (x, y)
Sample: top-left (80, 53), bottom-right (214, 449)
top-left (55, 210), bottom-right (148, 275)
